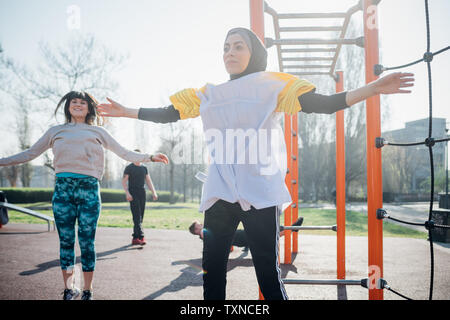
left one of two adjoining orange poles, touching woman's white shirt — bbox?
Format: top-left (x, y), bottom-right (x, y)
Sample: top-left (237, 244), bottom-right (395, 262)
top-left (284, 114), bottom-right (294, 264)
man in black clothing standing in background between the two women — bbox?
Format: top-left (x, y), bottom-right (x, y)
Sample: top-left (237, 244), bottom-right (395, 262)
top-left (122, 150), bottom-right (158, 245)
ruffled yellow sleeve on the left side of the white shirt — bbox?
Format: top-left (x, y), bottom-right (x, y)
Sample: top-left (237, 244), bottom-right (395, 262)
top-left (170, 87), bottom-right (206, 120)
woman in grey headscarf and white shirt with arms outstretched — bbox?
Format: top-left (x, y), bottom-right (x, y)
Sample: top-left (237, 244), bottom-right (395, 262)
top-left (99, 28), bottom-right (414, 300)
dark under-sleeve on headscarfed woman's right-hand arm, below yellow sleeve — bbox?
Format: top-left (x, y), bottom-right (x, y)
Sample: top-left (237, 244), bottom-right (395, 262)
top-left (298, 91), bottom-right (349, 114)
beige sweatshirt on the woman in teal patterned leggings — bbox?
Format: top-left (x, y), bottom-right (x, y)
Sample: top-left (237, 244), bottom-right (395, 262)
top-left (0, 123), bottom-right (150, 180)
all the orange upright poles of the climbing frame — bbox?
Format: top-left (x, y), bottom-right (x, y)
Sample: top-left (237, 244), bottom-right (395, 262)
top-left (249, 0), bottom-right (383, 300)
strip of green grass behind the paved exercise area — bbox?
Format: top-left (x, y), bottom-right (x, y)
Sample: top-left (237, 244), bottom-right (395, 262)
top-left (4, 202), bottom-right (427, 239)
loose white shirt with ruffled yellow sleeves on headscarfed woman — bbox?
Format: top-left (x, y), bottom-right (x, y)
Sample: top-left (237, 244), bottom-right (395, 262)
top-left (170, 72), bottom-right (315, 212)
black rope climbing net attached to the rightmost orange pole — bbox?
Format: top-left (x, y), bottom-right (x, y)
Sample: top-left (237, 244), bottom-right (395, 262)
top-left (374, 0), bottom-right (450, 300)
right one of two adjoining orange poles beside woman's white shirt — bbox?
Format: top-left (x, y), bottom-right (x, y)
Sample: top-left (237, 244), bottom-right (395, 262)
top-left (291, 114), bottom-right (300, 253)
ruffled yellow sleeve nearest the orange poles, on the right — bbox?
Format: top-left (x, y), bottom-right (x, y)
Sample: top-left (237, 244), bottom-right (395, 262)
top-left (272, 72), bottom-right (316, 114)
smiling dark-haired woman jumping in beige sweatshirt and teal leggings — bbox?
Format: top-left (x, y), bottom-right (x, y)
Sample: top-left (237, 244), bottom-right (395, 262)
top-left (0, 91), bottom-right (168, 300)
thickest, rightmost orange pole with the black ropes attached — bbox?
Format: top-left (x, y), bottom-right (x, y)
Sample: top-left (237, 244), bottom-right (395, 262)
top-left (363, 0), bottom-right (383, 300)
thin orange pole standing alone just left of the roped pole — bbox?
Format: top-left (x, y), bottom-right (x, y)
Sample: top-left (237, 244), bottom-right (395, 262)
top-left (336, 71), bottom-right (345, 279)
